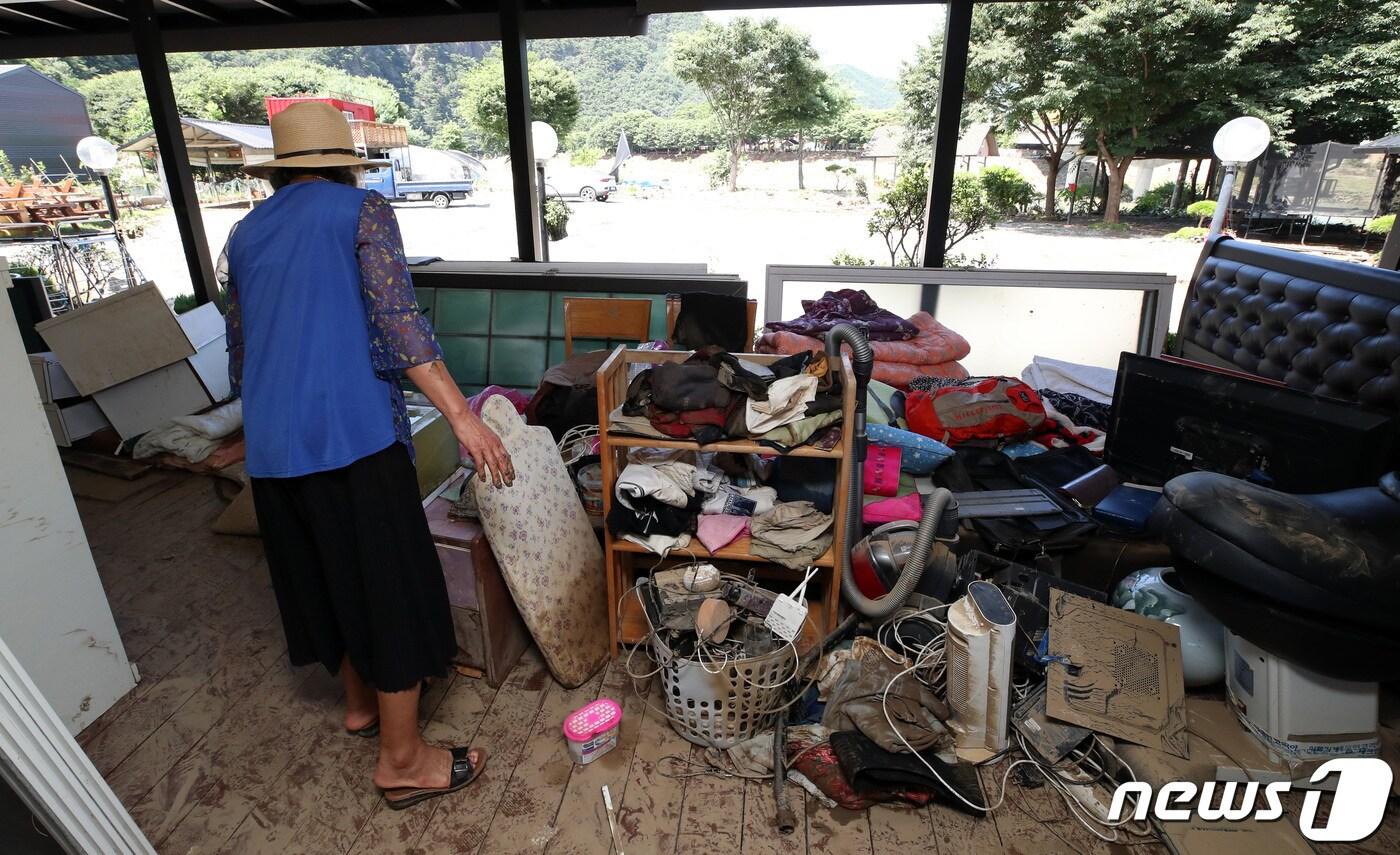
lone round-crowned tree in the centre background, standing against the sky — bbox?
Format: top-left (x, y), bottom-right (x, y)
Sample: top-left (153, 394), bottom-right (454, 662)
top-left (671, 18), bottom-right (816, 190)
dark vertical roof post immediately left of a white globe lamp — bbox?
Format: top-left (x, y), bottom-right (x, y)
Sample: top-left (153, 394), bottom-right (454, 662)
top-left (501, 0), bottom-right (545, 262)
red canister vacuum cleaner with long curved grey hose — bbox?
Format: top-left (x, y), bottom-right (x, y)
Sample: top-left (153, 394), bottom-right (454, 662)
top-left (826, 323), bottom-right (958, 620)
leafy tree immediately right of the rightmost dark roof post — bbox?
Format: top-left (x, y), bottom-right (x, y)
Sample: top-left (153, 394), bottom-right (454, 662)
top-left (966, 3), bottom-right (1084, 217)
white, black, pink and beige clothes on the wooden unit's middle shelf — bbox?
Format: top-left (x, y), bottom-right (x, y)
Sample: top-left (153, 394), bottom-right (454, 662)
top-left (608, 448), bottom-right (834, 568)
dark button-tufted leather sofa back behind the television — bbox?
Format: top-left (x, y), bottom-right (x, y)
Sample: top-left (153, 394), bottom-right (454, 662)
top-left (1177, 236), bottom-right (1400, 413)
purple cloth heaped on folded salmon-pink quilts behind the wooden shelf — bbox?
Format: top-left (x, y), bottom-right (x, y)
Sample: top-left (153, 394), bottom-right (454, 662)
top-left (756, 288), bottom-right (972, 389)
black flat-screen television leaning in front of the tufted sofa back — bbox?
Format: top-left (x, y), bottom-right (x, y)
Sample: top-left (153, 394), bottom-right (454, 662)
top-left (1105, 353), bottom-right (1400, 493)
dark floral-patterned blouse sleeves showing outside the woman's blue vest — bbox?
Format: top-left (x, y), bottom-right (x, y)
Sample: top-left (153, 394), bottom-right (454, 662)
top-left (216, 190), bottom-right (442, 458)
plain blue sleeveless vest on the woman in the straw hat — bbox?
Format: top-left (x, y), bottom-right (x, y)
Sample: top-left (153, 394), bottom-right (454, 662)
top-left (228, 181), bottom-right (395, 479)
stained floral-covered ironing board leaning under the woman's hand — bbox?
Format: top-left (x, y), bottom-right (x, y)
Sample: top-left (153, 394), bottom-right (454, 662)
top-left (472, 396), bottom-right (608, 688)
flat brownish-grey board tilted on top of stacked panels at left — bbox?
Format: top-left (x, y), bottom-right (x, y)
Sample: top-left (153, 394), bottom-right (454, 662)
top-left (34, 283), bottom-right (197, 395)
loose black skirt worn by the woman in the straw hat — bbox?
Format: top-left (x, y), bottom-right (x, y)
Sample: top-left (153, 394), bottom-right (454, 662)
top-left (252, 442), bottom-right (456, 691)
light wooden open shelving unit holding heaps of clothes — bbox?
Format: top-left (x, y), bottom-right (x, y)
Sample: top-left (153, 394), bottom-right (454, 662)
top-left (598, 347), bottom-right (855, 656)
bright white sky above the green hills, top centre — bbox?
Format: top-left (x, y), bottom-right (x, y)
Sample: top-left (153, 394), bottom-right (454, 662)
top-left (706, 4), bottom-right (945, 80)
